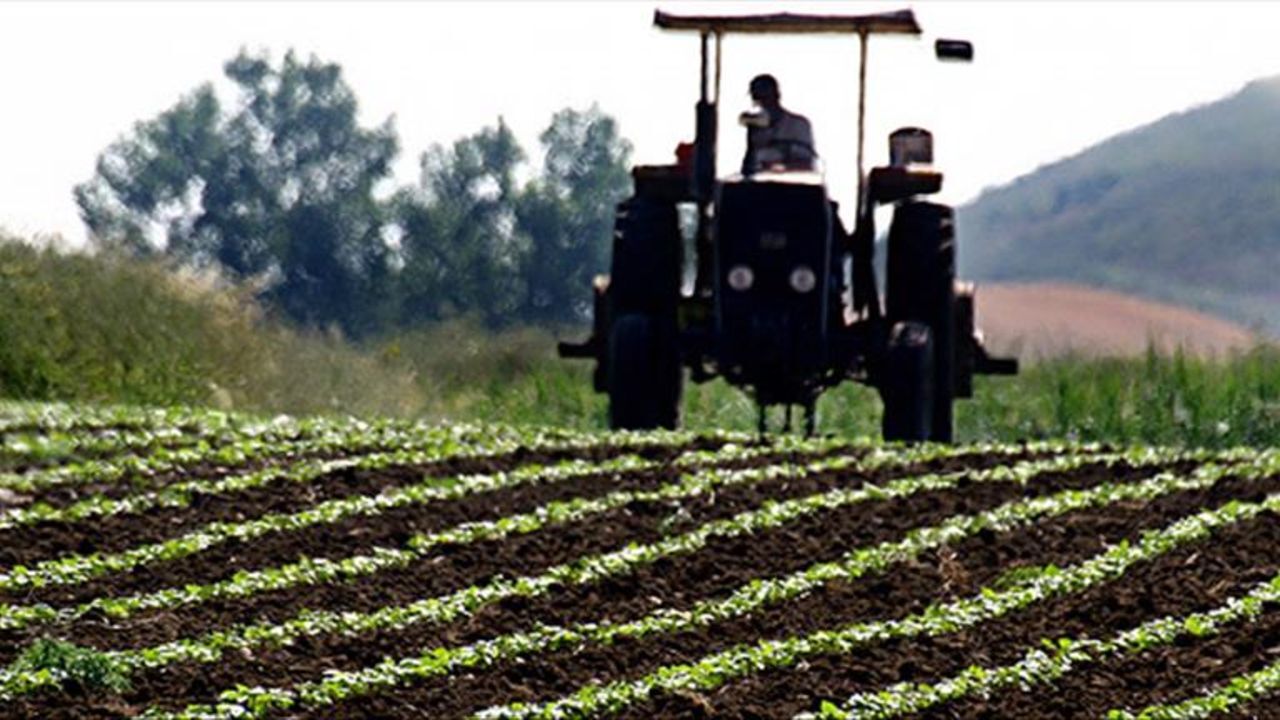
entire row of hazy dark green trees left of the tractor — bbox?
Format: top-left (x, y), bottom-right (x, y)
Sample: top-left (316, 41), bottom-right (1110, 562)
top-left (76, 51), bottom-right (630, 337)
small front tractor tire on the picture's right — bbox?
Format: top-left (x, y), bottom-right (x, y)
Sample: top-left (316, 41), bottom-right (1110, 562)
top-left (879, 322), bottom-right (937, 442)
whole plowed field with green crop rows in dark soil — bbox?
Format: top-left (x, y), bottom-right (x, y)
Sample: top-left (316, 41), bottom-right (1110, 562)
top-left (0, 404), bottom-right (1280, 720)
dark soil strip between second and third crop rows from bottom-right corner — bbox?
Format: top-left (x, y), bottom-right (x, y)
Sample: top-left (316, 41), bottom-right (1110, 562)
top-left (623, 504), bottom-right (1280, 720)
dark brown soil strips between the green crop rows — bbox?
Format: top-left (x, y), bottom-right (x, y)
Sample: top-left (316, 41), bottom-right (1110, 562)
top-left (12, 448), bottom-right (1280, 720)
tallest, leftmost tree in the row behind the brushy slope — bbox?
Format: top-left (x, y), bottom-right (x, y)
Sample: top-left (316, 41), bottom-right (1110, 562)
top-left (76, 51), bottom-right (398, 333)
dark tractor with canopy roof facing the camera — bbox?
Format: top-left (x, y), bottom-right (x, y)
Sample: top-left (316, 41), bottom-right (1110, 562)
top-left (559, 10), bottom-right (1018, 442)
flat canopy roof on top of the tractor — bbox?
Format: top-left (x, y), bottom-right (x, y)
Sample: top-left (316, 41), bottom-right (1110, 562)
top-left (653, 10), bottom-right (920, 35)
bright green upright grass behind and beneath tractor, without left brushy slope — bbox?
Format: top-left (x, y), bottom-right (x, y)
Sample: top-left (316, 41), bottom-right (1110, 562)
top-left (401, 336), bottom-right (1280, 447)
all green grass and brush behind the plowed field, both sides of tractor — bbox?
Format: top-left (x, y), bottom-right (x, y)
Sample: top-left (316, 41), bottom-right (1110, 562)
top-left (0, 233), bottom-right (1280, 447)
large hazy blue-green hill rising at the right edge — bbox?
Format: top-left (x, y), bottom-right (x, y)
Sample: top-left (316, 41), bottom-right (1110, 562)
top-left (957, 77), bottom-right (1280, 334)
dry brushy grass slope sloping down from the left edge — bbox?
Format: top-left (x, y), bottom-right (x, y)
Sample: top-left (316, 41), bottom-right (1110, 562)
top-left (0, 237), bottom-right (422, 415)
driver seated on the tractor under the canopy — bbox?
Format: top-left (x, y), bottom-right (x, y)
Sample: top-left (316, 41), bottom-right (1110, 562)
top-left (741, 74), bottom-right (818, 176)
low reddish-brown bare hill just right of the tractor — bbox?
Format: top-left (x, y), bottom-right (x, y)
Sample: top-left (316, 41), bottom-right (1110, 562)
top-left (977, 283), bottom-right (1257, 360)
